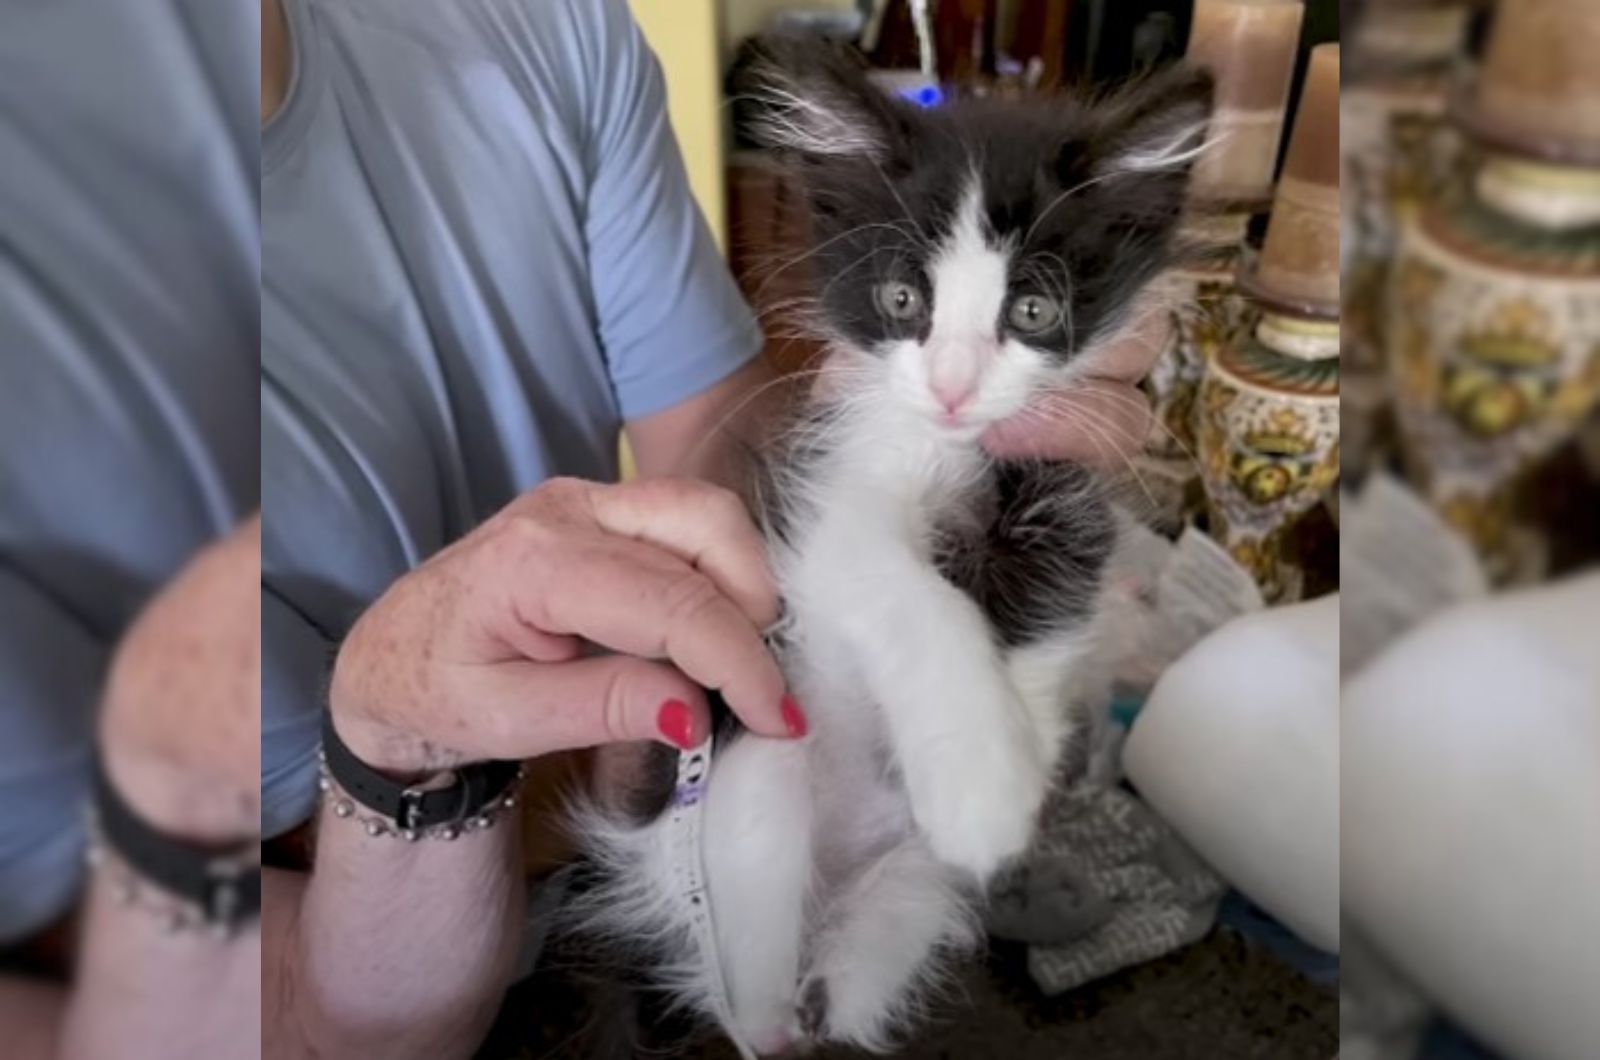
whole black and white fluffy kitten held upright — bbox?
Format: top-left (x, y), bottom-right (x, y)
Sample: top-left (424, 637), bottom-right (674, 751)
top-left (556, 40), bottom-right (1210, 1052)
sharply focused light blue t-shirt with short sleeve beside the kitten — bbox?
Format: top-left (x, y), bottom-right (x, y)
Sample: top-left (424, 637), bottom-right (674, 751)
top-left (261, 0), bottom-right (760, 836)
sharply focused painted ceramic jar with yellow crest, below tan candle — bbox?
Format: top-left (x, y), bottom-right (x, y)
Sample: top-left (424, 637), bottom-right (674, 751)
top-left (1197, 312), bottom-right (1339, 604)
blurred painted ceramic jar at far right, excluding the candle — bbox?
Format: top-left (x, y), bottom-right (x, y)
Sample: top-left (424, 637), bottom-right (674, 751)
top-left (1387, 159), bottom-right (1600, 583)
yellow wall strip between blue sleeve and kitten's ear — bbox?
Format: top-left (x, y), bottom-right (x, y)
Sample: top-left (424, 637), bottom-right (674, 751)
top-left (632, 0), bottom-right (738, 248)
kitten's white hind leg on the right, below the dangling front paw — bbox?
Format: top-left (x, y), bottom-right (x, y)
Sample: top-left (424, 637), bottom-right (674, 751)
top-left (795, 836), bottom-right (979, 1052)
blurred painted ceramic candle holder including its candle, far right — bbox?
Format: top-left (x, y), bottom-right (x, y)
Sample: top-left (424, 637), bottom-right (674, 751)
top-left (1387, 0), bottom-right (1600, 584)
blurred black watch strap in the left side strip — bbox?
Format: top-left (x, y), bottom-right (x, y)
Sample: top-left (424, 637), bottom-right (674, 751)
top-left (93, 756), bottom-right (261, 929)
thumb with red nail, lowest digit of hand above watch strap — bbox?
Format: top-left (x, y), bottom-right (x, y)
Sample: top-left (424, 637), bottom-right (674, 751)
top-left (469, 655), bottom-right (710, 759)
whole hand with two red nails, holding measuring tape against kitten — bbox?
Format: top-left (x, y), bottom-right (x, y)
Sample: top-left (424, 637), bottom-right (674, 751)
top-left (330, 479), bottom-right (805, 775)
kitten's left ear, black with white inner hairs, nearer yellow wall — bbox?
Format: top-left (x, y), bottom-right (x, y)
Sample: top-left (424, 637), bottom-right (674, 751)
top-left (730, 34), bottom-right (912, 163)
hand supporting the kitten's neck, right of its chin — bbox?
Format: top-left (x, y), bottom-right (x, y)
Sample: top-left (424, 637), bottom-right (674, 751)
top-left (982, 312), bottom-right (1171, 464)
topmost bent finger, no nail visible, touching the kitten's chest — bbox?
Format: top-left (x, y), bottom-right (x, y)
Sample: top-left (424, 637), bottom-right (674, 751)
top-left (592, 479), bottom-right (778, 628)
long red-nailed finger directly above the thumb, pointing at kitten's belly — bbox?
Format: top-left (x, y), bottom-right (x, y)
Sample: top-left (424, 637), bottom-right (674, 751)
top-left (501, 538), bottom-right (790, 737)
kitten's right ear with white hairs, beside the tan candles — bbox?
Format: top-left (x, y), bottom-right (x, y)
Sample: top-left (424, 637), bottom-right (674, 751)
top-left (1061, 62), bottom-right (1214, 179)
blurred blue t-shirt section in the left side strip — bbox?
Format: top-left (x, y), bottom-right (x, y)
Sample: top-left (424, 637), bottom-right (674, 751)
top-left (0, 0), bottom-right (261, 947)
